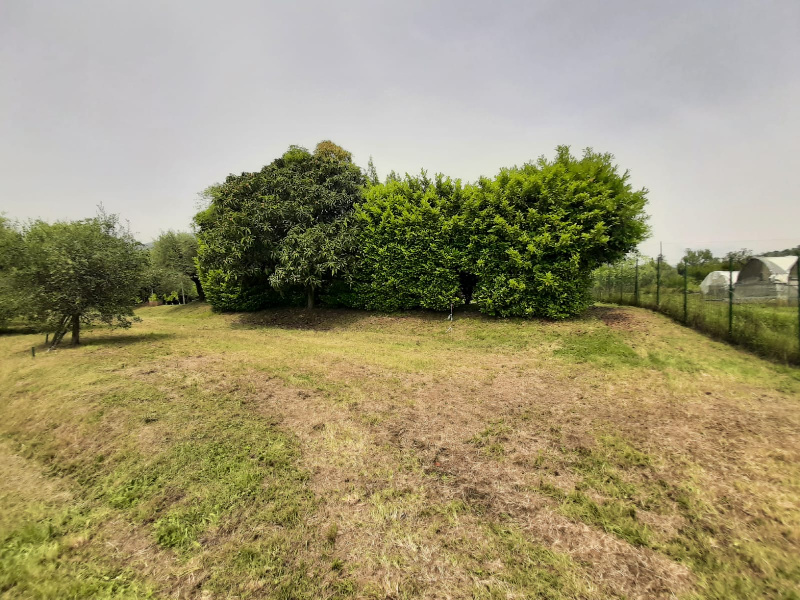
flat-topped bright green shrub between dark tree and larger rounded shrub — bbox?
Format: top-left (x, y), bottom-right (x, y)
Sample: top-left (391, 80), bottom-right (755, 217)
top-left (340, 173), bottom-right (464, 311)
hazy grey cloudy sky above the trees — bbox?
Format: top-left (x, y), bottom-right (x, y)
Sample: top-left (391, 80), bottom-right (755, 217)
top-left (0, 0), bottom-right (800, 260)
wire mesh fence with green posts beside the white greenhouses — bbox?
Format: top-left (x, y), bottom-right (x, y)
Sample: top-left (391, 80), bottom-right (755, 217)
top-left (594, 258), bottom-right (800, 364)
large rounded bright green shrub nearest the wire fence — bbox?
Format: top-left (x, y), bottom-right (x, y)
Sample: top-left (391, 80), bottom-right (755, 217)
top-left (464, 146), bottom-right (648, 318)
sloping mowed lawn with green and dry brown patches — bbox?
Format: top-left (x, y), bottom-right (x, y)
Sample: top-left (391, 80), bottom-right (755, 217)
top-left (0, 305), bottom-right (800, 600)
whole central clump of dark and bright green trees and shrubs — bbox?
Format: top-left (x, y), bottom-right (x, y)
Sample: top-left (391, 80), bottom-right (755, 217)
top-left (195, 141), bottom-right (648, 318)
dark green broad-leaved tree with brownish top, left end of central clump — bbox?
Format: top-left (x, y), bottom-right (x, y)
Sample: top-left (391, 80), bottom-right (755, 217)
top-left (195, 140), bottom-right (365, 310)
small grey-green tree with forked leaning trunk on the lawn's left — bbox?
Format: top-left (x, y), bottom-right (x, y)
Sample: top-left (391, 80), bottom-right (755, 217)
top-left (15, 211), bottom-right (147, 348)
